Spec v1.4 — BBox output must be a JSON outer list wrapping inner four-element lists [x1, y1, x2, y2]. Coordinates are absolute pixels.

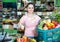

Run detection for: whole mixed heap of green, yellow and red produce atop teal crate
[[38, 19, 58, 30]]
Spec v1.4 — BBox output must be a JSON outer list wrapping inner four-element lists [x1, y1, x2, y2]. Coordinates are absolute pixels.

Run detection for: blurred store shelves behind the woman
[[0, 0, 60, 41]]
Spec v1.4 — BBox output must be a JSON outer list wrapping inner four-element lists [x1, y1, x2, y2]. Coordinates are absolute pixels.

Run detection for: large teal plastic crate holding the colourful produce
[[37, 28, 60, 42]]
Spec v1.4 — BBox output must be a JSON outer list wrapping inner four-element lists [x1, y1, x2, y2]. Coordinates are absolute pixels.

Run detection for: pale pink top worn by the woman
[[20, 15, 41, 37]]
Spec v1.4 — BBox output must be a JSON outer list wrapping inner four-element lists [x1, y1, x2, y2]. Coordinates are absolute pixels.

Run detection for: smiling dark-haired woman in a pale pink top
[[18, 3, 41, 38]]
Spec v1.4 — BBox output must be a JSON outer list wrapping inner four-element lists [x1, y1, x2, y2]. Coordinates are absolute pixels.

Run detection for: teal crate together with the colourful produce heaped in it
[[37, 14, 60, 42]]
